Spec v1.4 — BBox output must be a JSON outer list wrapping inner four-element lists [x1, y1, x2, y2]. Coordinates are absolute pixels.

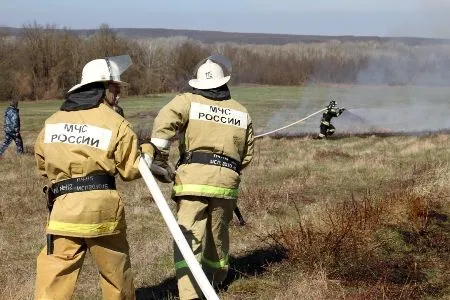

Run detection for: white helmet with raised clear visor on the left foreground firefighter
[[68, 55, 131, 93]]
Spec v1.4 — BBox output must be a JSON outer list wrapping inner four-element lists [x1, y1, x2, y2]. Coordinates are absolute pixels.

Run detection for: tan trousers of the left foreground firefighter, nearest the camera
[[35, 231, 135, 300]]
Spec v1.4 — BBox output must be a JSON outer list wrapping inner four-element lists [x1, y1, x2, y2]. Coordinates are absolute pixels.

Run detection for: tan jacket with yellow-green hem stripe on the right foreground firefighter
[[152, 92, 253, 199]]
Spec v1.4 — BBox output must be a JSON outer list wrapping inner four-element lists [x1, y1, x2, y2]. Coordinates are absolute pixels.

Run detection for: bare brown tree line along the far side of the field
[[0, 23, 450, 100]]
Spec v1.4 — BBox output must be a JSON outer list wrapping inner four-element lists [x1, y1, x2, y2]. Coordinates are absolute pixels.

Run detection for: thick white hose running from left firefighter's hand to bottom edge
[[139, 157, 219, 300]]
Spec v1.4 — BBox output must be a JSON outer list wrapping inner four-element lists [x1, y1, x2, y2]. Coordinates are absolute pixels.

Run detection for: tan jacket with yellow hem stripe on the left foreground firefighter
[[35, 103, 148, 237]]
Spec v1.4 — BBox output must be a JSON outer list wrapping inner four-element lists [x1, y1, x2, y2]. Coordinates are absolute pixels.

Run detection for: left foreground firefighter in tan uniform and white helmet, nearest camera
[[35, 56, 153, 299]]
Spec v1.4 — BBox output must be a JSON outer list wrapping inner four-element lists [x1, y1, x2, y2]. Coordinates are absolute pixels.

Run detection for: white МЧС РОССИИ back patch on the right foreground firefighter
[[189, 102, 247, 129]]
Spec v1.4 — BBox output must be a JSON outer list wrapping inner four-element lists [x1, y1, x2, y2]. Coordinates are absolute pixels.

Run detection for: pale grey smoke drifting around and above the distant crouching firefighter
[[257, 0, 450, 135]]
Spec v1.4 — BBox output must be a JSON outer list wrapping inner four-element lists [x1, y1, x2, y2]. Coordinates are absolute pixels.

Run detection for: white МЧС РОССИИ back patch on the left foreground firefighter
[[44, 123, 112, 150]]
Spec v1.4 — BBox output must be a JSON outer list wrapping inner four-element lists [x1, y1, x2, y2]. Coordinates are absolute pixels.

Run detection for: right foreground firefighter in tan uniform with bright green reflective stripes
[[151, 56, 253, 300]]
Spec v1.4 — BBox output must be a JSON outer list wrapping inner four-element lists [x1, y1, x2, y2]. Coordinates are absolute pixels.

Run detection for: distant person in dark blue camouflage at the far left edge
[[0, 100, 23, 157]]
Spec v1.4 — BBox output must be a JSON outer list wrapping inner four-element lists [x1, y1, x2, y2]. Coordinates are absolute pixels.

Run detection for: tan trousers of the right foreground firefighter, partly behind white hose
[[174, 196, 236, 300]]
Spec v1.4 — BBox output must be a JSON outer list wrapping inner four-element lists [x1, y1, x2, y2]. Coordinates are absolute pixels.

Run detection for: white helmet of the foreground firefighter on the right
[[189, 56, 230, 90]]
